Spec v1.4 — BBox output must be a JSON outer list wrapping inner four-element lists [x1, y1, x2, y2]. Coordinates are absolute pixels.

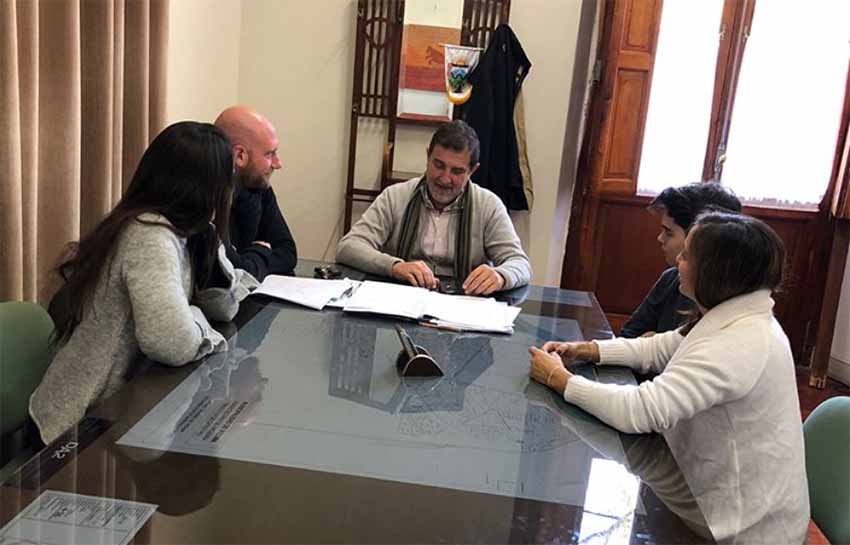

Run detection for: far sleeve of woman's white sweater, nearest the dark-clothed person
[[594, 330, 684, 373]]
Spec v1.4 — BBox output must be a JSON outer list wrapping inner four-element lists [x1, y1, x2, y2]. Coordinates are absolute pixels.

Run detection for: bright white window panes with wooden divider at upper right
[[638, 0, 850, 207]]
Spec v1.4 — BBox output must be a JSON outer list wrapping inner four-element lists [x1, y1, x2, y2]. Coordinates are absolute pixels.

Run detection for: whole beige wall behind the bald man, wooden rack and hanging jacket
[[168, 0, 581, 285]]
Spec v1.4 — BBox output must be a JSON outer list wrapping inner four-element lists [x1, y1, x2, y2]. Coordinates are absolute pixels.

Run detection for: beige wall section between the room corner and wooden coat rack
[[238, 0, 356, 259]]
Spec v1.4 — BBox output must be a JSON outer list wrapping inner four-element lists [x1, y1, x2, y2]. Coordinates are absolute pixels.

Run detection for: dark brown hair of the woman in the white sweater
[[687, 212, 785, 309]]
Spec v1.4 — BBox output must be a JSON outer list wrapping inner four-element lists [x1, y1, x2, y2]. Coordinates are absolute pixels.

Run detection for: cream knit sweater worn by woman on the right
[[564, 290, 809, 545]]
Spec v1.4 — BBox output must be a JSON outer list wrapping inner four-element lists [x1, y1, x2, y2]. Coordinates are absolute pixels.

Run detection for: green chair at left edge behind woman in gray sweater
[[0, 302, 53, 475]]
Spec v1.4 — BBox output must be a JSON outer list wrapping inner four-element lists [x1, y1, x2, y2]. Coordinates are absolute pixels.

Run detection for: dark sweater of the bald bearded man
[[227, 187, 298, 281]]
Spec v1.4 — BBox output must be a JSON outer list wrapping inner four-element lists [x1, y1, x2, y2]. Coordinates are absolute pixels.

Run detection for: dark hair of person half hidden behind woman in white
[[649, 182, 741, 231]]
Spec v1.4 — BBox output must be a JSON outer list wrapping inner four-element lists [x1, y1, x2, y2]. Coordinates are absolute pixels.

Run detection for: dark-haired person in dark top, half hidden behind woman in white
[[620, 182, 741, 338]]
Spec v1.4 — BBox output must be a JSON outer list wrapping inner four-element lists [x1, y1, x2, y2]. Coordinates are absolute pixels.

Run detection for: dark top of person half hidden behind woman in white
[[620, 267, 693, 338]]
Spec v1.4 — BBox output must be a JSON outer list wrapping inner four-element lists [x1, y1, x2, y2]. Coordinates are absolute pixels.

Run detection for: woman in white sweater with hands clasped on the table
[[529, 213, 809, 544]]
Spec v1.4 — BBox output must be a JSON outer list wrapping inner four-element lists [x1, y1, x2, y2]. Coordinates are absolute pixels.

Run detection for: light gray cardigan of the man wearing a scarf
[[336, 178, 531, 289]]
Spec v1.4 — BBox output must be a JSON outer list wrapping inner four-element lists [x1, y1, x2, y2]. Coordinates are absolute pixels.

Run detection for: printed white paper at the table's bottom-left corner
[[0, 490, 157, 545]]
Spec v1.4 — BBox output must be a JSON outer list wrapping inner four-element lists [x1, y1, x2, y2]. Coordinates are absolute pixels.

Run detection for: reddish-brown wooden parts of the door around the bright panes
[[561, 0, 829, 364]]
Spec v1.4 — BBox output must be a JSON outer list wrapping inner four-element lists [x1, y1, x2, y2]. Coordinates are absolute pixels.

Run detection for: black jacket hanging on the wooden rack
[[461, 24, 531, 210]]
